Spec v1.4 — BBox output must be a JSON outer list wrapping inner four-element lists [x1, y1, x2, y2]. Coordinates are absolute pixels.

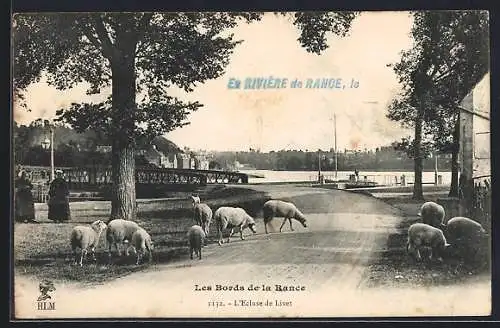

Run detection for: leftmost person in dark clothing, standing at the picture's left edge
[[14, 170, 36, 222]]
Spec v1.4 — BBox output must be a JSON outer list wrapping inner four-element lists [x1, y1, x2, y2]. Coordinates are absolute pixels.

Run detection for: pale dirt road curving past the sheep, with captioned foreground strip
[[16, 186, 488, 318]]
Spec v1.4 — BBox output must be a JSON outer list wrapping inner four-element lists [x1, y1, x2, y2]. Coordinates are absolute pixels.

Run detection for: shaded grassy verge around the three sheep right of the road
[[366, 191, 491, 288]]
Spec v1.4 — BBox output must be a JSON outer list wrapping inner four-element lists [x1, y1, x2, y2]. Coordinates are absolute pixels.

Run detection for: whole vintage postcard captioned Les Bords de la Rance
[[11, 10, 492, 320]]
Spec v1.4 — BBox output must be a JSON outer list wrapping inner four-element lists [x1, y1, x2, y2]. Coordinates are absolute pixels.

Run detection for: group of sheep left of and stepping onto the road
[[70, 196, 307, 266]]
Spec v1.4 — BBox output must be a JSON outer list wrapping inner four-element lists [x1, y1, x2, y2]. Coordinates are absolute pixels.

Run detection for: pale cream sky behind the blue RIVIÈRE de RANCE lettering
[[14, 12, 412, 151]]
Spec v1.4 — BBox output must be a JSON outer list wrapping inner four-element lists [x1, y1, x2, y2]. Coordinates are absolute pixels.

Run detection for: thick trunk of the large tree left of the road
[[111, 33, 137, 220]]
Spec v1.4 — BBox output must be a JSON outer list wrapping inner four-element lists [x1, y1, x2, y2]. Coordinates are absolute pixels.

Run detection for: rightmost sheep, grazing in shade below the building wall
[[444, 216, 488, 258]]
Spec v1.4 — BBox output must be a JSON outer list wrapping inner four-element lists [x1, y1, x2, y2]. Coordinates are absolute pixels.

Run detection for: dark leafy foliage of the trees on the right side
[[387, 10, 489, 152]]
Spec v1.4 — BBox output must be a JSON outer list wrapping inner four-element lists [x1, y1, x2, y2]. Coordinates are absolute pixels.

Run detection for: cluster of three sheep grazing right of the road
[[406, 202, 488, 262]]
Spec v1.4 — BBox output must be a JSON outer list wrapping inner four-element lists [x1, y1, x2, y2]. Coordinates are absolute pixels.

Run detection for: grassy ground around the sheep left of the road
[[14, 187, 268, 284]]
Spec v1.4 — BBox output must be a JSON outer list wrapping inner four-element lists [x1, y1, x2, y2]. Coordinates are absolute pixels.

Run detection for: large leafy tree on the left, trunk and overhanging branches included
[[13, 12, 355, 218]]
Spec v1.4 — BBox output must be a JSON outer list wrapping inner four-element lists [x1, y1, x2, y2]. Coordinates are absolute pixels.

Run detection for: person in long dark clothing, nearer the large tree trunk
[[47, 170, 71, 222]]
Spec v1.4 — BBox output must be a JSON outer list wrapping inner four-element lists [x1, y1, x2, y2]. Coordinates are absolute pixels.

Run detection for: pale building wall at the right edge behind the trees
[[459, 72, 491, 215]]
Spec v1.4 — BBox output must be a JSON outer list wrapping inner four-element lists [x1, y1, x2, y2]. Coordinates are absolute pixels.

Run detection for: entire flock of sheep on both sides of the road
[[71, 196, 487, 266]]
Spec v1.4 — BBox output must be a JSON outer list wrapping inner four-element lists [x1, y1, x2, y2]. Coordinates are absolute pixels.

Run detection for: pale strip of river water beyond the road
[[240, 170, 451, 185]]
